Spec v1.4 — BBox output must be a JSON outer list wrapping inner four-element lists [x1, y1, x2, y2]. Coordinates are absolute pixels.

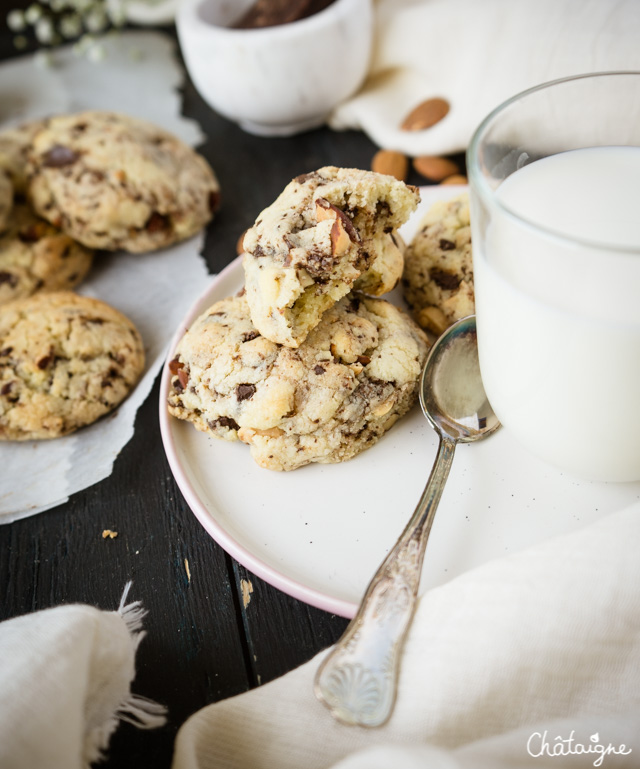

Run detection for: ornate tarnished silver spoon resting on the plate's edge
[[314, 316, 500, 726]]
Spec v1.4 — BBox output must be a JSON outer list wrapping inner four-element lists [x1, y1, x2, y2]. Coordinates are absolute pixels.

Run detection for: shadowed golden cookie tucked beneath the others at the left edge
[[0, 203, 93, 304]]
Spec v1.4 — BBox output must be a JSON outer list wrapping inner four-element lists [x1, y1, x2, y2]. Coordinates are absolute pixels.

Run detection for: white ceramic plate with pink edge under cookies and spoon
[[160, 187, 640, 617]]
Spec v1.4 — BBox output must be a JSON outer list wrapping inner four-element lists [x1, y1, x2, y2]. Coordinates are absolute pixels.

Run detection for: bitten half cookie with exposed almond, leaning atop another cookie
[[244, 166, 419, 347]]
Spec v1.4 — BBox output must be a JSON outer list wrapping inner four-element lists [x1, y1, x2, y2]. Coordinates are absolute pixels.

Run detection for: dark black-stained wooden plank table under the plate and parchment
[[0, 15, 462, 769]]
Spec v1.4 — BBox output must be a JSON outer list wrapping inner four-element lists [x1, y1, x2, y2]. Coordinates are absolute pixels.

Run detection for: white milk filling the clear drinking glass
[[472, 147, 640, 481]]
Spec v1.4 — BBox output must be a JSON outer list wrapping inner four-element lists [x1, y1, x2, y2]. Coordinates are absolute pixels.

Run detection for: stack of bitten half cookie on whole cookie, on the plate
[[169, 166, 428, 470]]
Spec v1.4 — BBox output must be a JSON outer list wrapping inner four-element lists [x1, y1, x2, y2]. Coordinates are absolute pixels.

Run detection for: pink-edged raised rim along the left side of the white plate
[[159, 256, 357, 618]]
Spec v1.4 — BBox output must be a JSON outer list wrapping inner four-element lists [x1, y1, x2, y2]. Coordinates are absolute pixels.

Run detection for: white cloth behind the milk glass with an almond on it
[[330, 0, 640, 157]]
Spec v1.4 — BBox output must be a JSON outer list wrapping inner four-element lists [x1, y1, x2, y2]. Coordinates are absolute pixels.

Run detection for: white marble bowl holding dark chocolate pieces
[[176, 0, 372, 136]]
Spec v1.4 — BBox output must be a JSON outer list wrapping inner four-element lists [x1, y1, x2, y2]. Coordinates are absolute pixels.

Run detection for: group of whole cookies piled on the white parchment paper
[[0, 111, 219, 440]]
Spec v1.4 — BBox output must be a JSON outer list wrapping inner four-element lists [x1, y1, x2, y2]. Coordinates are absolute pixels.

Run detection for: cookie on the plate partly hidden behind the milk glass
[[402, 193, 475, 334]]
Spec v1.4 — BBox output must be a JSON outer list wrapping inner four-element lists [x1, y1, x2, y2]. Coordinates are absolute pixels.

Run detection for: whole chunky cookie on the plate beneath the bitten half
[[169, 293, 428, 470]]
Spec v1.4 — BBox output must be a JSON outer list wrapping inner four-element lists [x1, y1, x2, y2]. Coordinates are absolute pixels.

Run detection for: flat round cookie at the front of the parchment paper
[[0, 291, 144, 441]]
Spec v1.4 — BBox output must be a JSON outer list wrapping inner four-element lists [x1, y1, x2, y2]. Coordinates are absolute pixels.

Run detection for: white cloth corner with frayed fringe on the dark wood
[[0, 583, 165, 769]]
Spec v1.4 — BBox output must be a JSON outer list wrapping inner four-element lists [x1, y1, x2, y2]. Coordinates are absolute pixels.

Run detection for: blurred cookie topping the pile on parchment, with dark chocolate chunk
[[27, 111, 219, 252]]
